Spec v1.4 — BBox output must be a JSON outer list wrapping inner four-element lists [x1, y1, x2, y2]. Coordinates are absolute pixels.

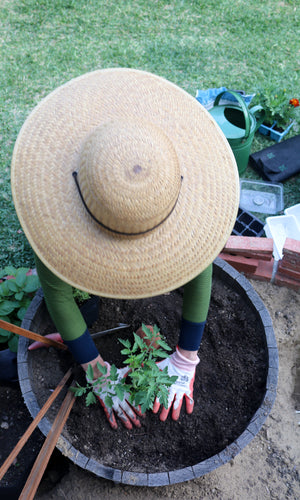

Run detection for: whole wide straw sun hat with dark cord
[[11, 68, 239, 298]]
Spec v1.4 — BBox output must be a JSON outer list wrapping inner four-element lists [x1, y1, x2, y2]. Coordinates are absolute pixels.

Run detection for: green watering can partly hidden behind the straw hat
[[209, 90, 265, 175]]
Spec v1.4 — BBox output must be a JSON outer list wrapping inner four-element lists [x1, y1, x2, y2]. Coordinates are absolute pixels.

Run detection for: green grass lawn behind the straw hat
[[0, 0, 300, 267]]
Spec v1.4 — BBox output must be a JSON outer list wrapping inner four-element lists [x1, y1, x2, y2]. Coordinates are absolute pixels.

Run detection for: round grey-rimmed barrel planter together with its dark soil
[[18, 259, 278, 487]]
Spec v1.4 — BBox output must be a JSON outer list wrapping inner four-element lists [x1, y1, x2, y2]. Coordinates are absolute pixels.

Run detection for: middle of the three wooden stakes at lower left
[[0, 368, 72, 481]]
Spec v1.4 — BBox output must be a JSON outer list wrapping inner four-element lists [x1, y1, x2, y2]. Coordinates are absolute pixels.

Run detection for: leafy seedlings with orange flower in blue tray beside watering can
[[256, 88, 299, 142]]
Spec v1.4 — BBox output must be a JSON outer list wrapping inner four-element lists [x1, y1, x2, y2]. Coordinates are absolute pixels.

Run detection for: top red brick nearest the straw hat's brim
[[223, 235, 273, 256]]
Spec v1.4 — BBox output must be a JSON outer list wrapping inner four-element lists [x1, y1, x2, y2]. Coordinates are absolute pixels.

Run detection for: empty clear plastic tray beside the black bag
[[240, 179, 284, 215]]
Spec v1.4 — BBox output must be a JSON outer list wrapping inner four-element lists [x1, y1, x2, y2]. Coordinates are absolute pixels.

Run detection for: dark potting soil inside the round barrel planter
[[30, 278, 267, 473]]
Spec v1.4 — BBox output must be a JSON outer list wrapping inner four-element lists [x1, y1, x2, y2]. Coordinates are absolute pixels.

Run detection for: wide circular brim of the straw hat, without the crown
[[11, 68, 239, 298]]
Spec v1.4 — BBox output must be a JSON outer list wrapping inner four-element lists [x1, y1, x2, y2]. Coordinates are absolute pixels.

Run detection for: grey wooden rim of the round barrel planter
[[18, 258, 278, 487]]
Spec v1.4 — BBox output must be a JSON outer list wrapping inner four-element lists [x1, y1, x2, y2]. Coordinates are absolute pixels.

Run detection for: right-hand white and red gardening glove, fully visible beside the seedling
[[153, 348, 200, 422]]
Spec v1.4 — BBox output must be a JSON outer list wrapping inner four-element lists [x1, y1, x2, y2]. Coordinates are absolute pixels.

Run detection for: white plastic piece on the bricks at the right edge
[[264, 215, 300, 260]]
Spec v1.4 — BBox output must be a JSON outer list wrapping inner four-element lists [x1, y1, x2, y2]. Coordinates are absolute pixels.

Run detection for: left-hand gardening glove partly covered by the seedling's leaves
[[86, 362, 143, 429]]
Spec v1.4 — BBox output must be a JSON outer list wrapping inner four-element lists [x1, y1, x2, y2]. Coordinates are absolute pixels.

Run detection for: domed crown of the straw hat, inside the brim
[[78, 119, 181, 234]]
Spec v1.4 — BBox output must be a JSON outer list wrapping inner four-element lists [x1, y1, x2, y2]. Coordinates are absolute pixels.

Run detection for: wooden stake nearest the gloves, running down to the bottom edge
[[19, 380, 75, 500]]
